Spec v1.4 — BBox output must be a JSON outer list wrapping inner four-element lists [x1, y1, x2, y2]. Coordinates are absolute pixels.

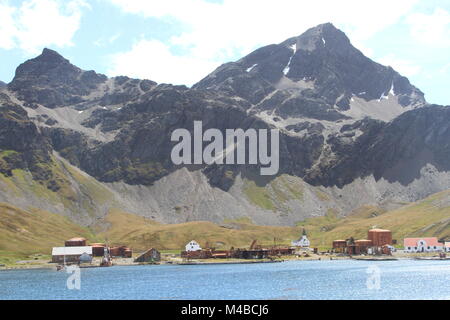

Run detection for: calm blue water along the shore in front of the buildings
[[0, 260, 450, 300]]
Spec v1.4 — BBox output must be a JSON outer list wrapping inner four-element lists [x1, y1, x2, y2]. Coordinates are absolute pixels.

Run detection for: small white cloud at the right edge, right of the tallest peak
[[406, 8, 450, 48]]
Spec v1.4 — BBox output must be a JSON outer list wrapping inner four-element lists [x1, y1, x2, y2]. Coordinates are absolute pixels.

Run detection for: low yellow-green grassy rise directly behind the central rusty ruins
[[99, 211, 300, 250]]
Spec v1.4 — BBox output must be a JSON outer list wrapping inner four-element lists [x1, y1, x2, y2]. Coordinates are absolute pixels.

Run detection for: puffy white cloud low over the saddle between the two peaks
[[107, 40, 216, 85]]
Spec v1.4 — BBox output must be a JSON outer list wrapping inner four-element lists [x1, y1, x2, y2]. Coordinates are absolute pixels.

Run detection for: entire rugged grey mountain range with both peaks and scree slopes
[[0, 24, 450, 226]]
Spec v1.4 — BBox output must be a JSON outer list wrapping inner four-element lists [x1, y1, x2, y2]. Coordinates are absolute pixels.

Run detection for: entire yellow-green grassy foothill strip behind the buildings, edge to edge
[[0, 190, 450, 263]]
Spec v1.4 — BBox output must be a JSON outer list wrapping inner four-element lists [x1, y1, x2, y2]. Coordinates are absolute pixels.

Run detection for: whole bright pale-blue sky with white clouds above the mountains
[[0, 0, 450, 105]]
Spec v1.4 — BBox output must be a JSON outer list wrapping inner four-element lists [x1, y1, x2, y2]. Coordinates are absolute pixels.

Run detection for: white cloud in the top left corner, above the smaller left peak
[[0, 0, 88, 54]]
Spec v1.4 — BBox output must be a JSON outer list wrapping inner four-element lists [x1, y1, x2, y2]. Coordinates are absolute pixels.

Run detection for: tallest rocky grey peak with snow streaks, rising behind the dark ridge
[[194, 23, 425, 121]]
